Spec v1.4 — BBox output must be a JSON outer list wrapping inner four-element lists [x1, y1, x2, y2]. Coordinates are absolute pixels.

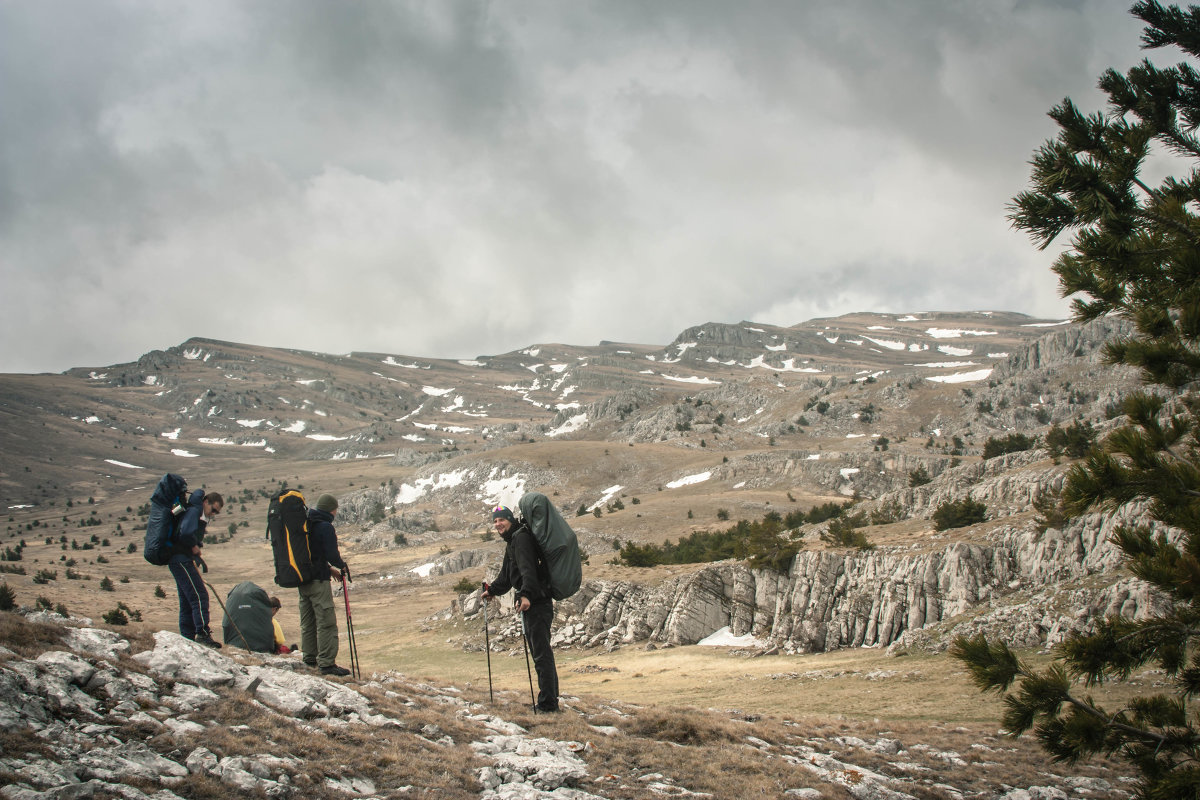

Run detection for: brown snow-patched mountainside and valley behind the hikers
[[0, 313, 1157, 800]]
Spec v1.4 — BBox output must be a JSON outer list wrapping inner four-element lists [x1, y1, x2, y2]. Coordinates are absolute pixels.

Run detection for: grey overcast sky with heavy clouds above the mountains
[[0, 0, 1161, 372]]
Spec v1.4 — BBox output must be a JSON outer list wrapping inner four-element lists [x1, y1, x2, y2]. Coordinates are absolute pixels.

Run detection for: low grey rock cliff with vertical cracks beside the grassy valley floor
[[549, 501, 1163, 652]]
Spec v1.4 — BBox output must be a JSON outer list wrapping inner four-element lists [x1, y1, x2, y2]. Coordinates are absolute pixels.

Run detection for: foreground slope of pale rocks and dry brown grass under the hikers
[[0, 613, 1132, 800]]
